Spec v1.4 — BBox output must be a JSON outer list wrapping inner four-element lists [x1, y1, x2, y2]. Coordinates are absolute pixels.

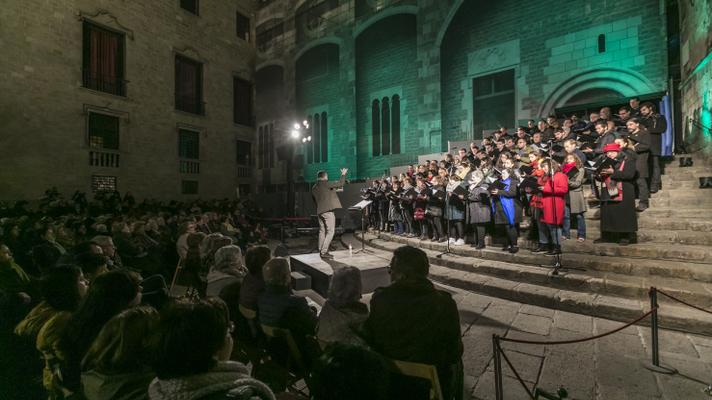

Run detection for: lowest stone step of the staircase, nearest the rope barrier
[[430, 265, 712, 335]]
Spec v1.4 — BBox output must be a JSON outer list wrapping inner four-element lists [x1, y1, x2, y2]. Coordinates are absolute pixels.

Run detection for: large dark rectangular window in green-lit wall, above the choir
[[472, 69, 514, 138]]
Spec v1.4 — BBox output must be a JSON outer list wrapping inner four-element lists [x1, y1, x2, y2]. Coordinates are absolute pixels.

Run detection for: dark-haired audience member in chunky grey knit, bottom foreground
[[148, 298, 275, 400]]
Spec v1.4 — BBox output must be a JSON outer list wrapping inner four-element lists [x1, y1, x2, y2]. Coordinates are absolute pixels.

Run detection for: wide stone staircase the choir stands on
[[358, 156, 712, 335]]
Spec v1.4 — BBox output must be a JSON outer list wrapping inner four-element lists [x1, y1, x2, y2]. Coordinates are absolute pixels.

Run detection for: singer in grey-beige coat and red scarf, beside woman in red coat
[[561, 153, 588, 242]]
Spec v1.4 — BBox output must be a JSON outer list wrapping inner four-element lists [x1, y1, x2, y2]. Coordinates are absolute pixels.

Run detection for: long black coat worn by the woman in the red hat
[[601, 153, 638, 232]]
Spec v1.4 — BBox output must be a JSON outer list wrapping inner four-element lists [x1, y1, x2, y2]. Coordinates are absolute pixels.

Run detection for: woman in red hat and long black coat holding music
[[594, 139, 638, 246]]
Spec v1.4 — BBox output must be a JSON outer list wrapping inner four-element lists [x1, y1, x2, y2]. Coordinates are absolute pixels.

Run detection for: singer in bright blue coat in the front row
[[489, 169, 522, 254]]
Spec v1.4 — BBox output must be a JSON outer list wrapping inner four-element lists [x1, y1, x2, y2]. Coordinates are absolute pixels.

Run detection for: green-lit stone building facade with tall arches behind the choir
[[255, 0, 709, 187]]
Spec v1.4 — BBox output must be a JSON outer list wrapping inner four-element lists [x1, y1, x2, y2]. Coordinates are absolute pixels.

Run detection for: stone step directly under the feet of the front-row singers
[[370, 233, 712, 283]]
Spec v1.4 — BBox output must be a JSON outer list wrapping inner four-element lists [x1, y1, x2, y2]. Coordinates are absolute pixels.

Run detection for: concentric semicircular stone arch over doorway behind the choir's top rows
[[538, 67, 656, 115]]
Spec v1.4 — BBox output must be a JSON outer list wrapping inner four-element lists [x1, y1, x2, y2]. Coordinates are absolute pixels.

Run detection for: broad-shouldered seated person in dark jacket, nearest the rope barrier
[[364, 246, 463, 399]]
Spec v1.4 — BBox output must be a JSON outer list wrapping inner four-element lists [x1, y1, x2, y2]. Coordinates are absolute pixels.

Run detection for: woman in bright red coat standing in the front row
[[536, 160, 569, 255]]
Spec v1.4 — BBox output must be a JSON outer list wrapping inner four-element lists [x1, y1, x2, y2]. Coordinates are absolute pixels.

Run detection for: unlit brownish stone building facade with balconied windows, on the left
[[0, 0, 255, 200]]
